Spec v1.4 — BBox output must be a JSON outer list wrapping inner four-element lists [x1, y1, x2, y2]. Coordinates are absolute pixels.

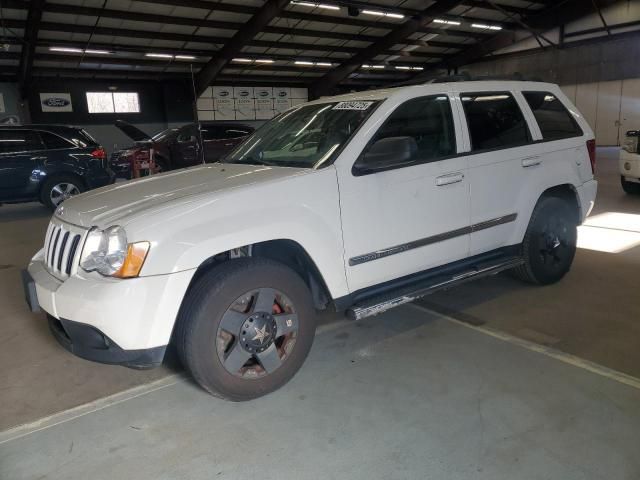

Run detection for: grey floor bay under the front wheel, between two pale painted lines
[[0, 306, 640, 480]]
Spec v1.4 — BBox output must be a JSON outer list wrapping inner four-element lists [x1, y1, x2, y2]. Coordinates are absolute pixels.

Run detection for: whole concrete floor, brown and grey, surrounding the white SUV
[[0, 150, 640, 480]]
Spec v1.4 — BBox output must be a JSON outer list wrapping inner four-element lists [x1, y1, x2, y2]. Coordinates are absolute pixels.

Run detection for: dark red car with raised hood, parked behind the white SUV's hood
[[110, 120, 254, 178]]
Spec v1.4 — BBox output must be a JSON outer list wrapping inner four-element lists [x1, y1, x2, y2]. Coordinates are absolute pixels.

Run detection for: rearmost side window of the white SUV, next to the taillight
[[522, 92, 583, 140]]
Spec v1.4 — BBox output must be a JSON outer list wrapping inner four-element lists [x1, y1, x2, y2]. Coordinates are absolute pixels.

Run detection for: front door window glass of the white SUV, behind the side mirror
[[365, 95, 456, 166]]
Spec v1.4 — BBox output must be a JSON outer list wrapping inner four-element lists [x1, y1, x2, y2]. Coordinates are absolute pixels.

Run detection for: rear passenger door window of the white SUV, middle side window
[[460, 92, 531, 152]]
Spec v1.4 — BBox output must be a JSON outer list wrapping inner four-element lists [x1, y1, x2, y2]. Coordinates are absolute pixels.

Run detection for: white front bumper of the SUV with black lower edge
[[23, 251, 195, 368]]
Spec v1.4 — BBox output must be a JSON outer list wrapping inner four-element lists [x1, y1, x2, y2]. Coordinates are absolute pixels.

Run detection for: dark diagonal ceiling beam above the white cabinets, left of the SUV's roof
[[195, 0, 289, 96]]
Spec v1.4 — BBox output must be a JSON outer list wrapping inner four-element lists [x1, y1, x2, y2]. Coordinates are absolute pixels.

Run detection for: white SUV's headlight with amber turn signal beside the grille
[[80, 226, 149, 278]]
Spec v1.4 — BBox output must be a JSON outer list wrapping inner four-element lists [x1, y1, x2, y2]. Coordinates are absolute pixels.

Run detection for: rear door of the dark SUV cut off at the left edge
[[0, 129, 47, 200]]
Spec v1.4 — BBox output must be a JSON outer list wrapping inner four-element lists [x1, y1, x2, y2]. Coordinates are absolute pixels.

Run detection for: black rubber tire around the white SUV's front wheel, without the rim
[[174, 258, 316, 401]]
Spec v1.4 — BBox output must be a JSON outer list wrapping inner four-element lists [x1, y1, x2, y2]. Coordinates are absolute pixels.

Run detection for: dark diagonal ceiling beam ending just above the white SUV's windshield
[[312, 0, 460, 96]]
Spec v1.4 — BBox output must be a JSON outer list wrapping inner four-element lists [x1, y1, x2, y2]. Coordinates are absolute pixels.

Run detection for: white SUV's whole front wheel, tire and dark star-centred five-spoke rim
[[175, 258, 315, 401]]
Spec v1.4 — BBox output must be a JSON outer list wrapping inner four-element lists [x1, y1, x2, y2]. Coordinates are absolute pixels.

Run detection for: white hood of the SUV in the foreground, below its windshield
[[55, 163, 313, 228]]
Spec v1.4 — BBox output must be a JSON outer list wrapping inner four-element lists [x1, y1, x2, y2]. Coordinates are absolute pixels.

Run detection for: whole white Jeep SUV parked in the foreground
[[23, 81, 596, 400]]
